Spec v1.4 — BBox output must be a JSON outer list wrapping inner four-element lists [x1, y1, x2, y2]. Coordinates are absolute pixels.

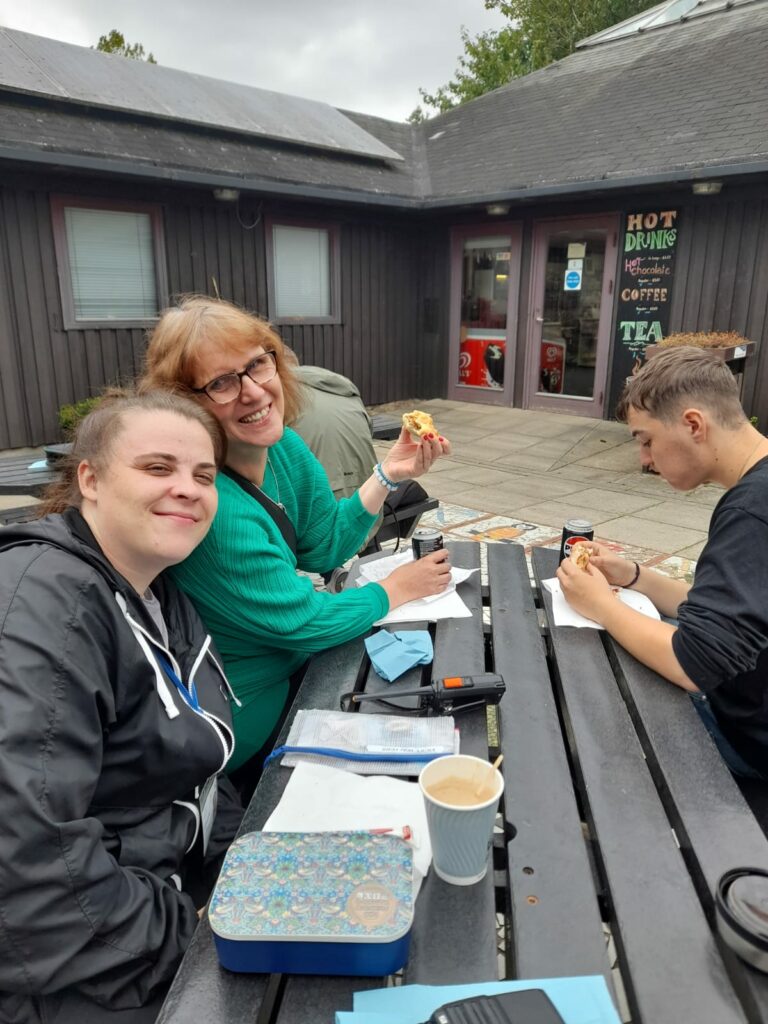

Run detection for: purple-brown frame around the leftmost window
[[50, 196, 168, 331]]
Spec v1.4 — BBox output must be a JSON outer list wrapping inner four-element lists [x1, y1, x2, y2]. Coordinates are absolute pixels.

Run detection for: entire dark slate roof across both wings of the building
[[0, 0, 768, 207]]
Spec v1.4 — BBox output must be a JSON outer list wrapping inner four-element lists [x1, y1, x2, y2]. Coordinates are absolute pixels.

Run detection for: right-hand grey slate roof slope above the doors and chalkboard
[[426, 0, 768, 201]]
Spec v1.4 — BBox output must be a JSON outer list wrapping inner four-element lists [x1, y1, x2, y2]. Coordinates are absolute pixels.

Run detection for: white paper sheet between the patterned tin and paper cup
[[264, 762, 432, 895]]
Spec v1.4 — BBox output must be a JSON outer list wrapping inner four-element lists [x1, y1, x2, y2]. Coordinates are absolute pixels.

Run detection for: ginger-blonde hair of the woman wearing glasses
[[139, 295, 301, 424]]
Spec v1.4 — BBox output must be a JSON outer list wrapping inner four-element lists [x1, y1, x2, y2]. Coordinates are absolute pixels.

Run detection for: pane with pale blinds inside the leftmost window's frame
[[65, 207, 158, 321]]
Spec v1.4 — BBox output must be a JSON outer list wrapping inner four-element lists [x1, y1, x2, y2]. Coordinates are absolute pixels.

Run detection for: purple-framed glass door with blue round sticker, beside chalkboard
[[526, 216, 617, 418]]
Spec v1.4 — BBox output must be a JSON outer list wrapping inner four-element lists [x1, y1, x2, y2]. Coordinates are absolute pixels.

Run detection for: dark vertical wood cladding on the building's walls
[[0, 175, 768, 449]]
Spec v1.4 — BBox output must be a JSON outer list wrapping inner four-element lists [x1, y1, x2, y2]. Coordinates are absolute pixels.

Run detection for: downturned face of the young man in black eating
[[627, 408, 708, 490]]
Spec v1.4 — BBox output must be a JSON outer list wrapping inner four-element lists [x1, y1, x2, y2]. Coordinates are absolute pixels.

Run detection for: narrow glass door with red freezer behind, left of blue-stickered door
[[450, 224, 520, 402]]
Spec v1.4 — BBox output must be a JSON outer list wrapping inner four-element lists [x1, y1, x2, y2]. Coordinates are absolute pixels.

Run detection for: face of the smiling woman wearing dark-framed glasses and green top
[[194, 345, 285, 454]]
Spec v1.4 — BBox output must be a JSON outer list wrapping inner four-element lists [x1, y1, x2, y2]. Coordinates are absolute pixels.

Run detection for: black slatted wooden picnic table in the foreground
[[159, 542, 768, 1024]]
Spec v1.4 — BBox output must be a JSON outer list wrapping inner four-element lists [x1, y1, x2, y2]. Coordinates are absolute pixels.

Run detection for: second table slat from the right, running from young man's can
[[532, 550, 744, 1024]]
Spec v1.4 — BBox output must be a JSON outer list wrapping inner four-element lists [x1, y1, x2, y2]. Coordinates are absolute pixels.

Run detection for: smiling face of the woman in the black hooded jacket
[[78, 410, 218, 593]]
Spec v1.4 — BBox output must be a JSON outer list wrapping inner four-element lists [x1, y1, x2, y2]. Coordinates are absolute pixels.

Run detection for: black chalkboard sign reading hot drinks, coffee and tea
[[610, 210, 679, 407]]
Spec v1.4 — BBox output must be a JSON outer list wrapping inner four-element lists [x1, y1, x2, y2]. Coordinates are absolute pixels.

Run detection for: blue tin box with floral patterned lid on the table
[[208, 831, 414, 976]]
